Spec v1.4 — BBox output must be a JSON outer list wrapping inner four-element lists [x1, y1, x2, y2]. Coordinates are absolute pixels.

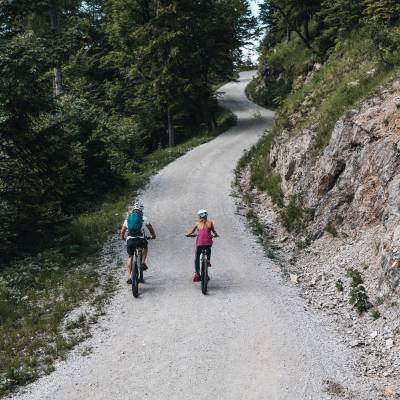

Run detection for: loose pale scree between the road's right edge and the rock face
[[237, 165, 400, 400]]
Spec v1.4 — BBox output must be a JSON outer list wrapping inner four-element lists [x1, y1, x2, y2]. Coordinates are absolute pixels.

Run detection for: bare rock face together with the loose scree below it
[[237, 79, 400, 399]]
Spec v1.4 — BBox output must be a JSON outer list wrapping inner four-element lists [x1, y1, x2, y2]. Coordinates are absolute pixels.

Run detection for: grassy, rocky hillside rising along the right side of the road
[[237, 2, 400, 398]]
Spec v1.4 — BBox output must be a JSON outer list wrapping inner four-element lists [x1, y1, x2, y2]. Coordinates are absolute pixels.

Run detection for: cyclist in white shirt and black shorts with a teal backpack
[[120, 202, 156, 284]]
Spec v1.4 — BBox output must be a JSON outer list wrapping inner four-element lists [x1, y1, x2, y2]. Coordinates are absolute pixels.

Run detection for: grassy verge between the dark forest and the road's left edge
[[0, 109, 236, 396]]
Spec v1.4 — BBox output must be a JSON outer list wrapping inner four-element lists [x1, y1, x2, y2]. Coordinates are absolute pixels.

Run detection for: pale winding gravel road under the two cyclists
[[13, 72, 363, 400]]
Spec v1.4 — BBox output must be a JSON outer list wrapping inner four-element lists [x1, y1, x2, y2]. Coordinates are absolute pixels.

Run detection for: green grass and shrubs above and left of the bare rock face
[[238, 27, 400, 242]]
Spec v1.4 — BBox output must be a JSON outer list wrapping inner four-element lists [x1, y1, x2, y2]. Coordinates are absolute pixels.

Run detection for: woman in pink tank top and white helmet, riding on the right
[[186, 210, 219, 282]]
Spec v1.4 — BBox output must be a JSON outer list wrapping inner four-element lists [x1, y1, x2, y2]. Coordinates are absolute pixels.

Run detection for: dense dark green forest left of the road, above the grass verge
[[0, 0, 255, 261]]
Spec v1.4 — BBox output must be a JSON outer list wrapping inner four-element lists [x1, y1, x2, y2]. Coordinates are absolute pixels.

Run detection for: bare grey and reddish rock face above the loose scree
[[270, 79, 400, 291]]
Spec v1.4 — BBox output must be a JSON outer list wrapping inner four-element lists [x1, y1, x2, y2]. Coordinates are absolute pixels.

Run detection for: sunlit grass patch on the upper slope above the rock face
[[278, 31, 399, 151]]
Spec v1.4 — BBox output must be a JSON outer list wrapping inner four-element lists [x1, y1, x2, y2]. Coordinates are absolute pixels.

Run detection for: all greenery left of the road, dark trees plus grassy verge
[[0, 0, 256, 395]]
